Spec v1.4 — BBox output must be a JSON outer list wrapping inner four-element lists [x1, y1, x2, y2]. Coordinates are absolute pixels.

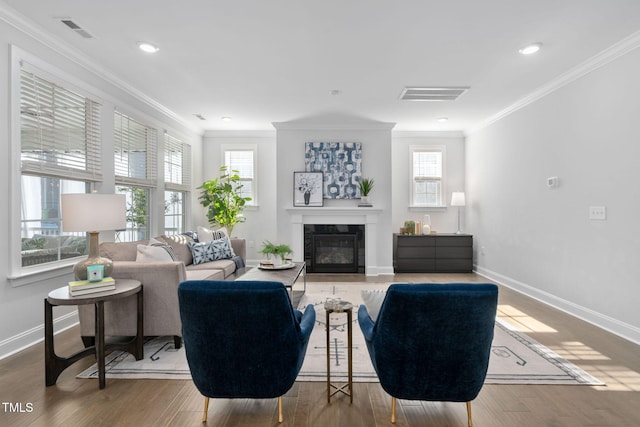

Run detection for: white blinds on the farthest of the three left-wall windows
[[164, 133, 191, 191]]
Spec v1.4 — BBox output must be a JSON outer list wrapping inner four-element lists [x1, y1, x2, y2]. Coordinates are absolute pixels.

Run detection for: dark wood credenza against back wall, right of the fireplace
[[393, 234, 473, 273]]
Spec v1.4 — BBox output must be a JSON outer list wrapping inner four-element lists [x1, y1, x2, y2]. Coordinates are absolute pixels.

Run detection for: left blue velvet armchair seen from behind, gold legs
[[178, 280, 315, 422]]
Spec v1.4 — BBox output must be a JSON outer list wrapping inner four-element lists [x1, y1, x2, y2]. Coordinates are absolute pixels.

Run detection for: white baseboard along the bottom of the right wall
[[475, 266, 640, 345]]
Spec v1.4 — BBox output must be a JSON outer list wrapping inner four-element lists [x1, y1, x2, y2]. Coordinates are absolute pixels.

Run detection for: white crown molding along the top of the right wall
[[465, 31, 640, 136]]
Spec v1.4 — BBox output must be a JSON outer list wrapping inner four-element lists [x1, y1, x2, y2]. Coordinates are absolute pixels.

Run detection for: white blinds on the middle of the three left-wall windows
[[114, 111, 158, 187]]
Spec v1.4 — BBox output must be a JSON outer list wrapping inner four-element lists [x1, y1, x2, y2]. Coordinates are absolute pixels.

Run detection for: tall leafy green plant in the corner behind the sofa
[[198, 166, 251, 235]]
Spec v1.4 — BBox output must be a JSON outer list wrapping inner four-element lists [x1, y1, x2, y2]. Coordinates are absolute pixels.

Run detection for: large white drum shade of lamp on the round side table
[[62, 193, 127, 232]]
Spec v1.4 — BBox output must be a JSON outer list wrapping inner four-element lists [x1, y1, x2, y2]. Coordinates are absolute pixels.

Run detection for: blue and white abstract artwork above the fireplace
[[304, 142, 362, 199]]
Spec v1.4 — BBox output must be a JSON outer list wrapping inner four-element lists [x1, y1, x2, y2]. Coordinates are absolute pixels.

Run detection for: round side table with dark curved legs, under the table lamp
[[44, 279, 144, 389]]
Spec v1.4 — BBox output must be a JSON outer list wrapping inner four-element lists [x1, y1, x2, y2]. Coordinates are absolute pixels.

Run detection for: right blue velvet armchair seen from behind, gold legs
[[358, 283, 498, 427]]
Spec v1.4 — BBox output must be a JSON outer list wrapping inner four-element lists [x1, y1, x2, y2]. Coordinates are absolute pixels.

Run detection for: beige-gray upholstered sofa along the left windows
[[78, 235, 246, 348]]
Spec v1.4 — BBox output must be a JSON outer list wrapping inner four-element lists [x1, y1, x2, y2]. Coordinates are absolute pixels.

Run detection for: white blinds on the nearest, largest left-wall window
[[20, 69, 102, 181]]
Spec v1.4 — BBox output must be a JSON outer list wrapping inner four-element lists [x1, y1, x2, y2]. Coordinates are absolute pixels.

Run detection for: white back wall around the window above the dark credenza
[[392, 132, 468, 233]]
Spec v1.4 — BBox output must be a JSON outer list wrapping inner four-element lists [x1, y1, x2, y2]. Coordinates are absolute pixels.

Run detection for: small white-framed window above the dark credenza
[[410, 146, 444, 207]]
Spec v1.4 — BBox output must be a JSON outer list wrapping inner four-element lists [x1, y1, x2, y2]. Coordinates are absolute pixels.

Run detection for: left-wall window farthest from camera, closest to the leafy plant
[[164, 133, 191, 234]]
